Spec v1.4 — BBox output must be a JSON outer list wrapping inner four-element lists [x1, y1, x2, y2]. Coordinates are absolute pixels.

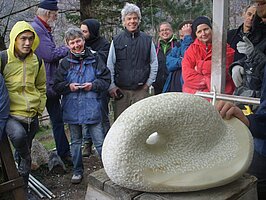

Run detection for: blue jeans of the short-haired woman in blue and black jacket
[[68, 123, 104, 175]]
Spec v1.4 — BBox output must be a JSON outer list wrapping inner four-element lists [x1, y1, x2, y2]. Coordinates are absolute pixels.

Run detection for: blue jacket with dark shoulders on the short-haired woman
[[53, 48, 111, 124]]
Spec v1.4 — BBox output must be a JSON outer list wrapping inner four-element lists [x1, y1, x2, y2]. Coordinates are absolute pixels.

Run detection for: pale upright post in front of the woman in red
[[211, 0, 229, 93]]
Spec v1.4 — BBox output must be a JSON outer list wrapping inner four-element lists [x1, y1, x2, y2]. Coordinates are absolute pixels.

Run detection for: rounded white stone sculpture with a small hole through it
[[102, 93, 253, 192]]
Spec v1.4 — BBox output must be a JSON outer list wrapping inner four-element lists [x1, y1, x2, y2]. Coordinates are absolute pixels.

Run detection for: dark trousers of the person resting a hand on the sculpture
[[248, 151, 266, 200]]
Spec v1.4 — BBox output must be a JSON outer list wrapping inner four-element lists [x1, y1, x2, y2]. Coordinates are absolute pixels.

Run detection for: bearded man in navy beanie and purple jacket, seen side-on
[[31, 0, 72, 164]]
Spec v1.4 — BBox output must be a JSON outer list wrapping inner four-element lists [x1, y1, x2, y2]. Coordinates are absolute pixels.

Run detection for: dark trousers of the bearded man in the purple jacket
[[46, 97, 70, 158]]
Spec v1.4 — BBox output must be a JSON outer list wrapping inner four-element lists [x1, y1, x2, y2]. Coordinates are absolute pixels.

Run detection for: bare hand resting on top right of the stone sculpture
[[215, 101, 249, 126]]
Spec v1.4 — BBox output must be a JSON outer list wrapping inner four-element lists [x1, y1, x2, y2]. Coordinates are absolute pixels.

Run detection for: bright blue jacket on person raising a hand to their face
[[163, 35, 193, 92]]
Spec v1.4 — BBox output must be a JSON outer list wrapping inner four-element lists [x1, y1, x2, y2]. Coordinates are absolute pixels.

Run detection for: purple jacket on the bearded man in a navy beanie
[[31, 17, 69, 98]]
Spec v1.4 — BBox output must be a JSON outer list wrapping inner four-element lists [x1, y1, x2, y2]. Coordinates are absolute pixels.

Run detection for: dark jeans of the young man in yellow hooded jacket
[[5, 116, 39, 187]]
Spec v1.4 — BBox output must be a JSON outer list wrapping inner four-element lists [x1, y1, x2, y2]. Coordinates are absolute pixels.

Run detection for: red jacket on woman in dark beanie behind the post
[[182, 39, 235, 94]]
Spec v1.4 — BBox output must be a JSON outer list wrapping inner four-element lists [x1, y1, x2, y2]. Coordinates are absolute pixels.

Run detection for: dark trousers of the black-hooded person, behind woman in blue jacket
[[83, 91, 111, 143]]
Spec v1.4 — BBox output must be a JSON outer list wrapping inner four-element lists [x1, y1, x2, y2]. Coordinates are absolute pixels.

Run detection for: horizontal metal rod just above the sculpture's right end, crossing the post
[[195, 92, 260, 105]]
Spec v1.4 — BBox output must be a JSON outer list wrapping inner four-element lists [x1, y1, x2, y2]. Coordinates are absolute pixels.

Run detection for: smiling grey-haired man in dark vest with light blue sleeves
[[107, 3, 158, 119]]
